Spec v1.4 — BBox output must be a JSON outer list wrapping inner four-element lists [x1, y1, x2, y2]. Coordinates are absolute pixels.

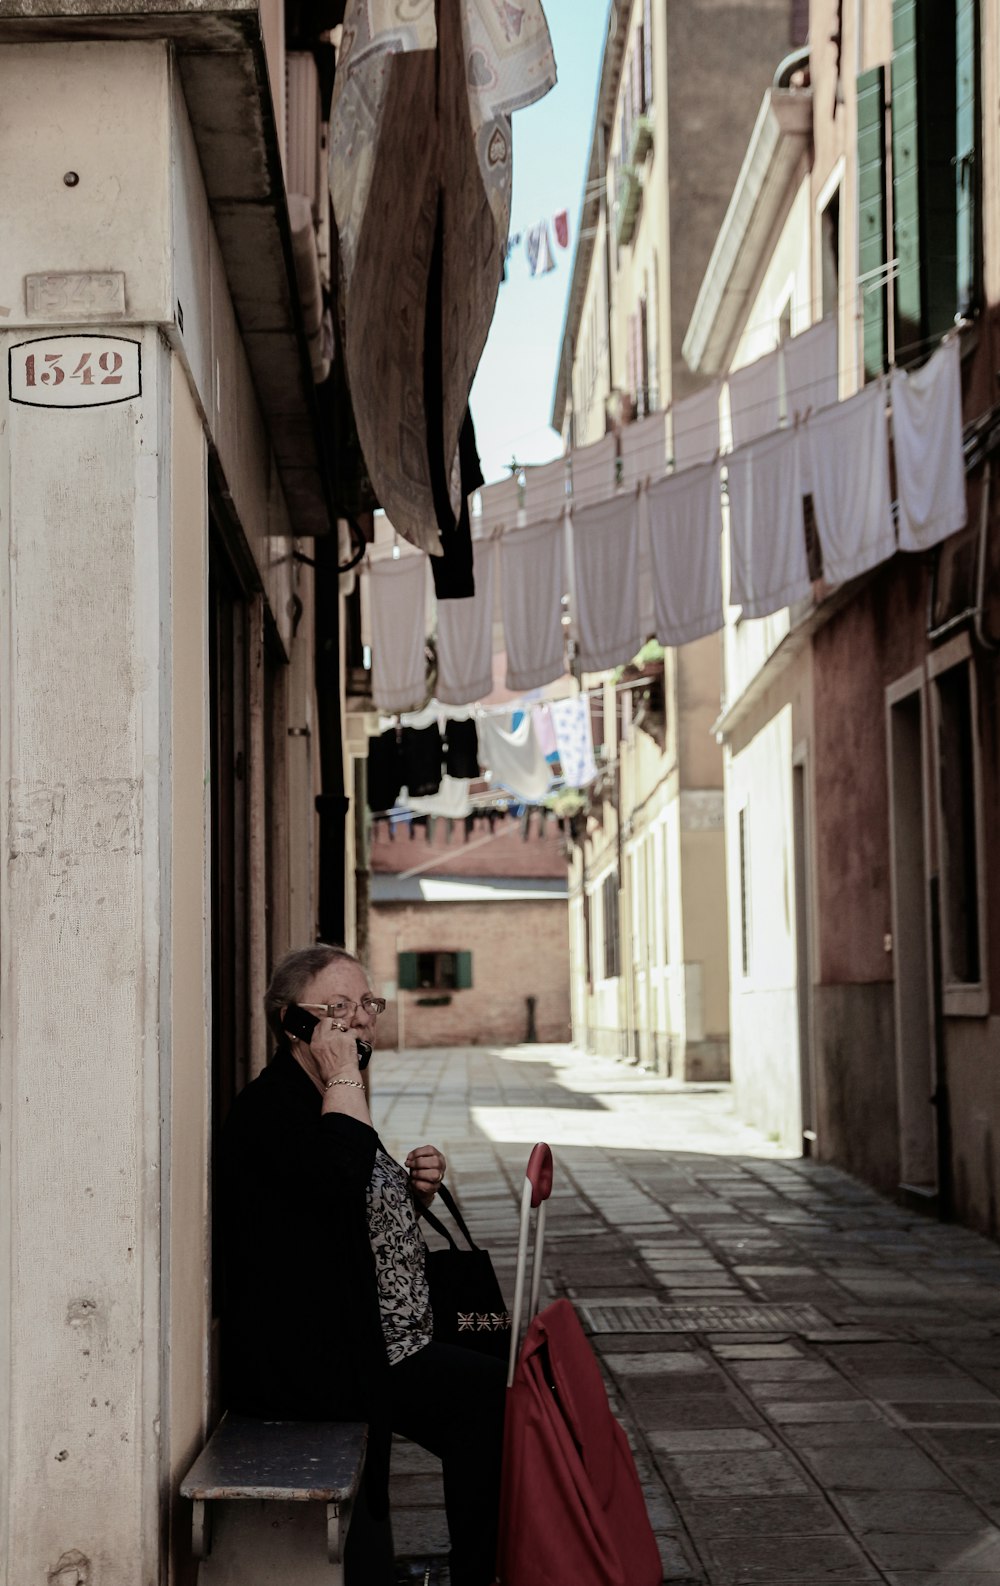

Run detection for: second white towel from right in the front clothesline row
[[805, 381, 895, 584]]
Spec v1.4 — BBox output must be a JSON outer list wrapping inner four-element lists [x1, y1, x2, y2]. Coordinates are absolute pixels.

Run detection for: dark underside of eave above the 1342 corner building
[[0, 0, 333, 536]]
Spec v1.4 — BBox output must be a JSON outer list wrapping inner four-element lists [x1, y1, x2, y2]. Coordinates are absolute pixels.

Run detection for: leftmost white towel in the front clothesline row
[[368, 552, 426, 712]]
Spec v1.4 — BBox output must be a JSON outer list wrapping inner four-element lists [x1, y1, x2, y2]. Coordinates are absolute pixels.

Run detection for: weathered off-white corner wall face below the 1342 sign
[[0, 325, 170, 1586]]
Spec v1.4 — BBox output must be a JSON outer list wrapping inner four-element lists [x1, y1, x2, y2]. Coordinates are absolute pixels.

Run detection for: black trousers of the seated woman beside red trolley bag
[[388, 1343, 507, 1586]]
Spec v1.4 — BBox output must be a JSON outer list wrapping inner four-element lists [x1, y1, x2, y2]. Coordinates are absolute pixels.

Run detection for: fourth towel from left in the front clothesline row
[[572, 495, 642, 672]]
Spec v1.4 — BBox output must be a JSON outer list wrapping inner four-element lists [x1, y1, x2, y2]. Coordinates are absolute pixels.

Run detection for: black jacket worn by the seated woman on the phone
[[216, 1047, 390, 1511]]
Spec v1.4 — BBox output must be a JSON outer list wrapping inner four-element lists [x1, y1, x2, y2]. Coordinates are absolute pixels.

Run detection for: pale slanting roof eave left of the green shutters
[[681, 87, 813, 374]]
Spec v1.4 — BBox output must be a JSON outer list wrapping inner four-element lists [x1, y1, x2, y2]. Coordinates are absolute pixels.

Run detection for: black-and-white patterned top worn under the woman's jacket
[[368, 1145, 433, 1366]]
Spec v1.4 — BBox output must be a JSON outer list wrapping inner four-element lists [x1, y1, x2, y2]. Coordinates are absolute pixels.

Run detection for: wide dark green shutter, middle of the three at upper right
[[892, 0, 957, 363]]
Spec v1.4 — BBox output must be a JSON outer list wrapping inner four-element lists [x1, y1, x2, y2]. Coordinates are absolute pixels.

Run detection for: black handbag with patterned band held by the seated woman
[[423, 1185, 510, 1361]]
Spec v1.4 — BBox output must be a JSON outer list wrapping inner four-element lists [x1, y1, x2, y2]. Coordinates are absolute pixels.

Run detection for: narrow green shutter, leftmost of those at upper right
[[857, 67, 887, 379]]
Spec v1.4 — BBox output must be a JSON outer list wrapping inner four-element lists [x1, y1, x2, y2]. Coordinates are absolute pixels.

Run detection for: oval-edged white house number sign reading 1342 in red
[[8, 335, 143, 408]]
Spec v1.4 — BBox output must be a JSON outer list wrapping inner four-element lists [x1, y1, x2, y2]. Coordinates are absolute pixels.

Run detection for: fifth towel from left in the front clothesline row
[[648, 463, 724, 646]]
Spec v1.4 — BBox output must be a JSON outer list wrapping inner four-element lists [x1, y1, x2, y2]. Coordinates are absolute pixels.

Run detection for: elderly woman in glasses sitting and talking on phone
[[217, 944, 504, 1586]]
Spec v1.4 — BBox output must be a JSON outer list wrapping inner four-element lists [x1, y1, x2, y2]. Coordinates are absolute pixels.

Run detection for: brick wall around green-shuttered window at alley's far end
[[369, 899, 569, 1047]]
